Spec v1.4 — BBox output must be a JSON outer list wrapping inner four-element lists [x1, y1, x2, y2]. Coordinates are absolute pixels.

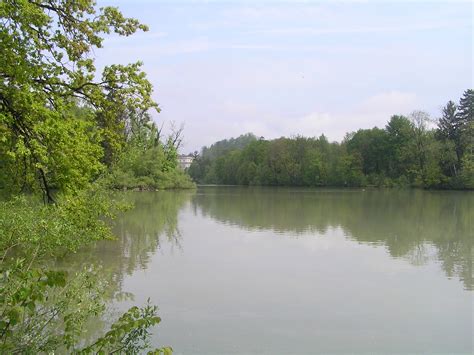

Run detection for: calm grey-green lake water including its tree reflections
[[68, 187, 474, 354]]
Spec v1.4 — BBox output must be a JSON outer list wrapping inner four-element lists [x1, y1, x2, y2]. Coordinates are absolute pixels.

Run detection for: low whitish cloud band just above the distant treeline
[[181, 91, 419, 149]]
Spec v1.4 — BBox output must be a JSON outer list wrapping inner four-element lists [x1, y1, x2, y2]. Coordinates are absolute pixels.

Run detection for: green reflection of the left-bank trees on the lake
[[56, 191, 194, 299]]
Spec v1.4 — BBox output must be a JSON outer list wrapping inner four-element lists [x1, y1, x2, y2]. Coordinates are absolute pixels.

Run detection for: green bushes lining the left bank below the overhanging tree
[[0, 190, 170, 353]]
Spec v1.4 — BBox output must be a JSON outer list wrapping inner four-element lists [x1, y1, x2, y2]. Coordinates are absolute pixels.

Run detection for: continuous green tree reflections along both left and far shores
[[58, 187, 474, 297]]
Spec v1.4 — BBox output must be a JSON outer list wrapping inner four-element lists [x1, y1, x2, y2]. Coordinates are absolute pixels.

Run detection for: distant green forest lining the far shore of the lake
[[188, 89, 474, 189]]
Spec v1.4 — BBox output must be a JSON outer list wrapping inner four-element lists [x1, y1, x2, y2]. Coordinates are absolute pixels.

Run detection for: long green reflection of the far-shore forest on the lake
[[192, 187, 474, 290]]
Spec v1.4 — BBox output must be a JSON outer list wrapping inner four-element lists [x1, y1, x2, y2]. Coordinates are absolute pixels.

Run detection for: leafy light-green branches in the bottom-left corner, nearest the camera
[[0, 261, 171, 354]]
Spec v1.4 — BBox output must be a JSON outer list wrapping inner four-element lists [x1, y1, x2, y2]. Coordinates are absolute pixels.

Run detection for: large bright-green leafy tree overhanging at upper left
[[0, 0, 157, 202]]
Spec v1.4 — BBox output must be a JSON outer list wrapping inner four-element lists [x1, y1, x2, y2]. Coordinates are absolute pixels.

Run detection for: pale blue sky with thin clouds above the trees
[[95, 0, 474, 153]]
